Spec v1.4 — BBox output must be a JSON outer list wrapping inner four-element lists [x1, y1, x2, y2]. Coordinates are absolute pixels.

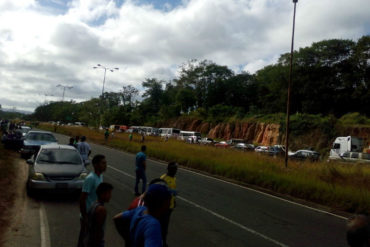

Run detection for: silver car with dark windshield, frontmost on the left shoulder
[[27, 144, 87, 194]]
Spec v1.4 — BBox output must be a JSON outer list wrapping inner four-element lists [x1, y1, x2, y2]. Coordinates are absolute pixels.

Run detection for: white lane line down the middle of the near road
[[108, 166, 288, 247]]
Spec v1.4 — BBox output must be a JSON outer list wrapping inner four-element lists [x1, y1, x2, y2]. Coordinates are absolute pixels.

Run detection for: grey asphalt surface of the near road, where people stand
[[27, 134, 347, 247]]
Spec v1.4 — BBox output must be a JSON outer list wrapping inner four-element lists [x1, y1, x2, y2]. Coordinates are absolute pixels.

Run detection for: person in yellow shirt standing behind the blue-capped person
[[160, 162, 178, 247]]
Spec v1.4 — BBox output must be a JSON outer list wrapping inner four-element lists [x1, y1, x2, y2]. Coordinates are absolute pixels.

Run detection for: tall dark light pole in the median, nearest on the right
[[285, 0, 298, 167]]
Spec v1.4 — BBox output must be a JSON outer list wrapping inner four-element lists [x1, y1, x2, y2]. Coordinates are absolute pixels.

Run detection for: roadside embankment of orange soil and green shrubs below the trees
[[157, 114, 370, 153]]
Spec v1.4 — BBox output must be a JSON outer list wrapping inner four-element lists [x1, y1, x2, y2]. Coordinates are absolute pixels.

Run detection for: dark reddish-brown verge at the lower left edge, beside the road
[[0, 145, 17, 246]]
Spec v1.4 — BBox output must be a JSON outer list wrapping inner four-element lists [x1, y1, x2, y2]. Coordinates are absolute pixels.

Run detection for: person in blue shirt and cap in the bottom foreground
[[113, 184, 171, 247]]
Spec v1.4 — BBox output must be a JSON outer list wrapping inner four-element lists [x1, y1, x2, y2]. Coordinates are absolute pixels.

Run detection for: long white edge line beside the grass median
[[62, 134, 348, 220]]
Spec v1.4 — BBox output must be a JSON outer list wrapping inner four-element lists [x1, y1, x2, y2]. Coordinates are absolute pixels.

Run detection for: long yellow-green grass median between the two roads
[[39, 124, 370, 213]]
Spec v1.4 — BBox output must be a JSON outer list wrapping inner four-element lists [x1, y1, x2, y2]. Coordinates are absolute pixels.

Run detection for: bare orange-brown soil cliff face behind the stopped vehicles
[[158, 118, 370, 152]]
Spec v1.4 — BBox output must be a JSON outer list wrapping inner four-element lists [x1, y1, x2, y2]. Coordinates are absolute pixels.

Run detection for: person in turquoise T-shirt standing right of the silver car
[[77, 154, 107, 247]]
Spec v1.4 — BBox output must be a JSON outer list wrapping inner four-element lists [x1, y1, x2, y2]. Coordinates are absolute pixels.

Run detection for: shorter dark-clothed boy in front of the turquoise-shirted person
[[85, 183, 113, 247]]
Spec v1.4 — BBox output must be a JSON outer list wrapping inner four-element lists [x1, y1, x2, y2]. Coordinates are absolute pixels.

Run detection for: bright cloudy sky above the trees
[[0, 0, 370, 111]]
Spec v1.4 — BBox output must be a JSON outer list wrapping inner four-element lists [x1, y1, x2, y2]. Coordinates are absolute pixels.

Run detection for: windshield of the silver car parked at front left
[[37, 149, 82, 165]]
